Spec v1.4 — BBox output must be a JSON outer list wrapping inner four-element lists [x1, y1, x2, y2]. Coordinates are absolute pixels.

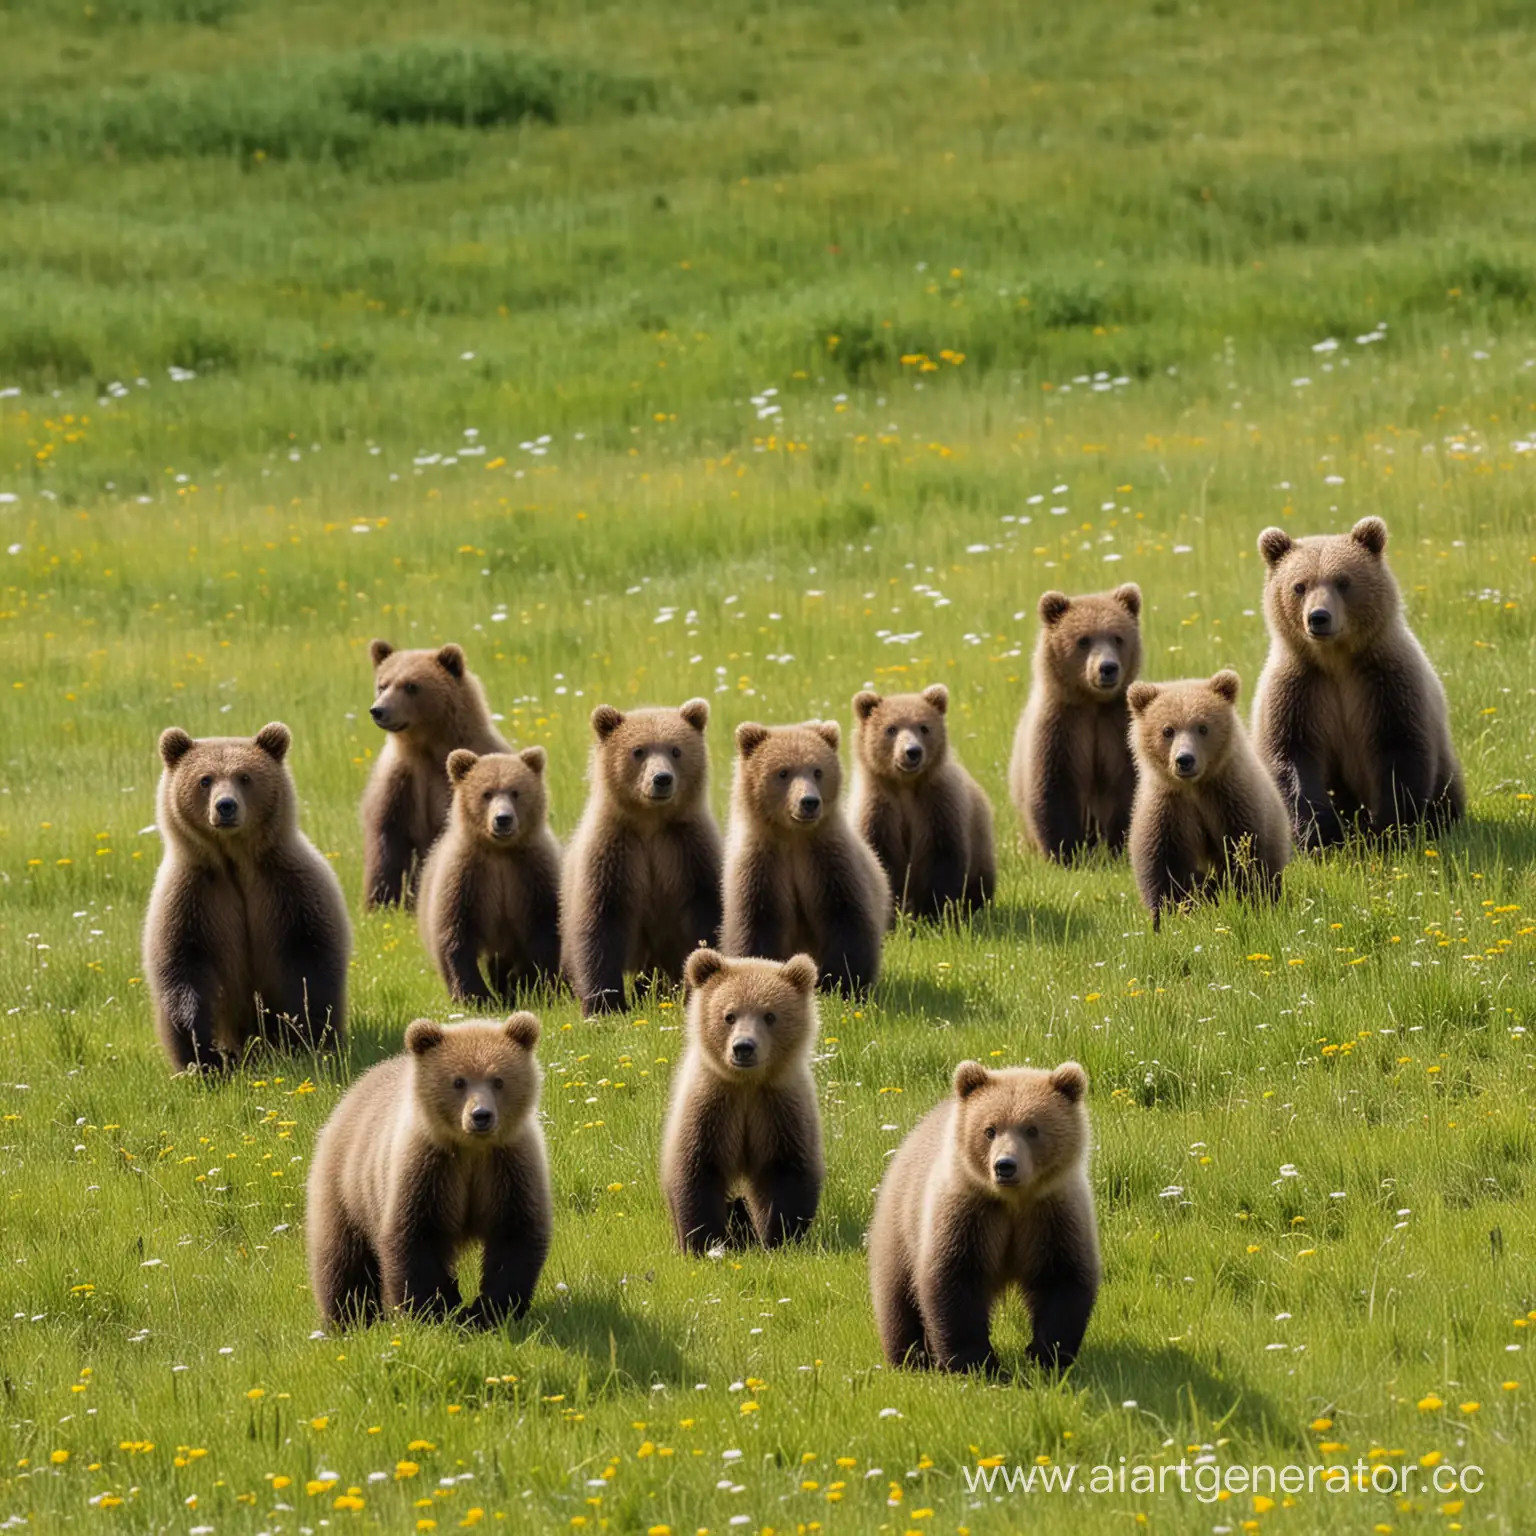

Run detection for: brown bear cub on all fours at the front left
[[309, 1014, 553, 1327]]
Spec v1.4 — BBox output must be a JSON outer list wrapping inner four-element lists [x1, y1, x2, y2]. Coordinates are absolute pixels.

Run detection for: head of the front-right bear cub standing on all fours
[[954, 1061, 1089, 1200]]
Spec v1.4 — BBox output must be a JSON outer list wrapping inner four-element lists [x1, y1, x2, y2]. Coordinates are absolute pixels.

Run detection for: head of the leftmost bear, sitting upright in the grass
[[158, 720, 298, 851]]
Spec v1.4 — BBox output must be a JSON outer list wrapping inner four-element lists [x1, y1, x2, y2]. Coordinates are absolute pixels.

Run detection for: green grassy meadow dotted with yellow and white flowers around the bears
[[0, 0, 1536, 1536]]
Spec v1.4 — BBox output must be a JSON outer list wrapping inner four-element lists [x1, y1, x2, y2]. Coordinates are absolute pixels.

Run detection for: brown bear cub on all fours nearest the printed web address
[[869, 1061, 1100, 1370]]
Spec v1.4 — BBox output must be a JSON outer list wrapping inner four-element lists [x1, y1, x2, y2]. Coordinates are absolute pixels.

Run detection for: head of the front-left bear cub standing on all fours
[[406, 1012, 542, 1147]]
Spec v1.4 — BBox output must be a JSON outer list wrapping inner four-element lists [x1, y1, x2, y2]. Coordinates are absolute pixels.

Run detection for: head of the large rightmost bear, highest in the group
[[1258, 518, 1402, 659]]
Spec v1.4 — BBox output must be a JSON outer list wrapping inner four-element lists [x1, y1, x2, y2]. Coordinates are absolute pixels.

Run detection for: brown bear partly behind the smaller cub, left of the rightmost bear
[[1008, 584, 1141, 860]]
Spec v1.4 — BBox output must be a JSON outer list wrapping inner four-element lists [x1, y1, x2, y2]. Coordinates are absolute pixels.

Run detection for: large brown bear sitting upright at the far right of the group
[[1253, 518, 1467, 848]]
